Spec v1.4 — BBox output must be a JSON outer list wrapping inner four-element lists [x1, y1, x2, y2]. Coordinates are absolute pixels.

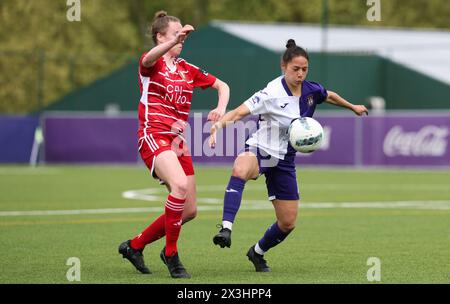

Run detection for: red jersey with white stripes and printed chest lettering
[[138, 53, 216, 139]]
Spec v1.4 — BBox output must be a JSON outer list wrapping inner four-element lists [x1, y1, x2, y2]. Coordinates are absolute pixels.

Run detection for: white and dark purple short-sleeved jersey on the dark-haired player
[[244, 76, 327, 161]]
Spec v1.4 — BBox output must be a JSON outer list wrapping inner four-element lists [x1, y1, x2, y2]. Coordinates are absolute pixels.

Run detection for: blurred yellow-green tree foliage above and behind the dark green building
[[0, 0, 450, 113]]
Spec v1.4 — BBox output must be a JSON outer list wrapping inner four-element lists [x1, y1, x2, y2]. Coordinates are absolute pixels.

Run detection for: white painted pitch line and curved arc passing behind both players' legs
[[0, 188, 450, 217]]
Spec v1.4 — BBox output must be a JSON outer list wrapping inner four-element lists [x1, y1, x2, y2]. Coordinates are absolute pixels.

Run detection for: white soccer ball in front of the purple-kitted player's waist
[[288, 117, 323, 153]]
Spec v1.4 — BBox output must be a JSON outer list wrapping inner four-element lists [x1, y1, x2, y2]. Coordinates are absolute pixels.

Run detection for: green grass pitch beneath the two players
[[0, 166, 450, 283]]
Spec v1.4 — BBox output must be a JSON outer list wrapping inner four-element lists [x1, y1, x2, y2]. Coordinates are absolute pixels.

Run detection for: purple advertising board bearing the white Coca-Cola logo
[[362, 115, 450, 166]]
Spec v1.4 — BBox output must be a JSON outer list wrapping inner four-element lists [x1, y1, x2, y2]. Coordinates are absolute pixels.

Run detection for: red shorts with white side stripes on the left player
[[139, 133, 194, 178]]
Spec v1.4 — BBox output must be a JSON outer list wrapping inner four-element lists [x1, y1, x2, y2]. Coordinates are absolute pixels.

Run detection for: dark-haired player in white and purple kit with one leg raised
[[210, 39, 368, 272]]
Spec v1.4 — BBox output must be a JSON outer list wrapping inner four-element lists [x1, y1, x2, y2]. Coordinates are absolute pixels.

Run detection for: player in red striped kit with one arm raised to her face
[[119, 11, 230, 278]]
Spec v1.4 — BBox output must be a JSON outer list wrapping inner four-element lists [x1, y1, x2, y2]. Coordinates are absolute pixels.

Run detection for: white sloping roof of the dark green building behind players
[[212, 21, 450, 85]]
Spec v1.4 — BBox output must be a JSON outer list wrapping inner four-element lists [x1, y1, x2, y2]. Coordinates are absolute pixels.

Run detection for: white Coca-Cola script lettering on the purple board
[[383, 125, 449, 157]]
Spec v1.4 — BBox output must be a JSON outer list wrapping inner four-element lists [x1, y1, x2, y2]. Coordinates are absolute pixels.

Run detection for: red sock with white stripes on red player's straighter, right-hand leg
[[165, 194, 186, 256]]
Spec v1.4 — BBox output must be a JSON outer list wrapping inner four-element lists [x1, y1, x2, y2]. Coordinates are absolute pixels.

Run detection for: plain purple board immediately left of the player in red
[[44, 116, 138, 163]]
